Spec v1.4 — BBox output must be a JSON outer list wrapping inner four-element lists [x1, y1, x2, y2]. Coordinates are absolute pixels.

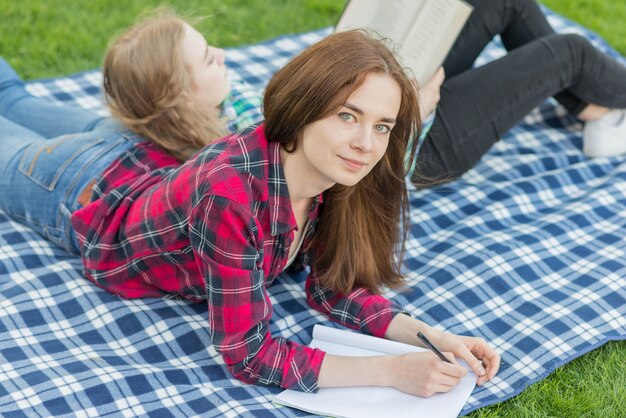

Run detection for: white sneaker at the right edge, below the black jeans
[[583, 109, 626, 158]]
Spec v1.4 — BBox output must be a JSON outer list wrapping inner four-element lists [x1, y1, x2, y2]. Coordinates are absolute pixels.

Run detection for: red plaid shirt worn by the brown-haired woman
[[72, 125, 401, 391]]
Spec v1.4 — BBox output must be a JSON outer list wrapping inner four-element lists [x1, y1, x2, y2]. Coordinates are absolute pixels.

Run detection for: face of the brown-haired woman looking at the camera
[[296, 74, 402, 188]]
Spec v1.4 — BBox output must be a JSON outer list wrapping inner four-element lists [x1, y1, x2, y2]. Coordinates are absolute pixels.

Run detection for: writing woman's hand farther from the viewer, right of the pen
[[428, 329, 500, 386]]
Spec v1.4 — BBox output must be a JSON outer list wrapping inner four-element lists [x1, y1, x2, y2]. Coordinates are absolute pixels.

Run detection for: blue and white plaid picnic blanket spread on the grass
[[0, 8, 626, 417]]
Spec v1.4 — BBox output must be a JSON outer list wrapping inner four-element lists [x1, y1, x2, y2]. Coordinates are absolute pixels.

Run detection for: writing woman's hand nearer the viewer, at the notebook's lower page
[[389, 352, 467, 397]]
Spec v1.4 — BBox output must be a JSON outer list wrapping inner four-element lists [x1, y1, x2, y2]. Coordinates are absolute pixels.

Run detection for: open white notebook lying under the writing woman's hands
[[273, 325, 477, 418]]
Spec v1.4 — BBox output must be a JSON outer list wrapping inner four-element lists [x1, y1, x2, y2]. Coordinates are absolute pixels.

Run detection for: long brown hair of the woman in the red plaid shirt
[[263, 30, 421, 293]]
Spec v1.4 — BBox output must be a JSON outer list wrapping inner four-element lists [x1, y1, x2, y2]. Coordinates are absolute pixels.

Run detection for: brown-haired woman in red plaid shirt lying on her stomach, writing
[[0, 27, 499, 396]]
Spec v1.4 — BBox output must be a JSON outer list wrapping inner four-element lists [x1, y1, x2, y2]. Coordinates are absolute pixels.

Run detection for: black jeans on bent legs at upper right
[[412, 0, 626, 184]]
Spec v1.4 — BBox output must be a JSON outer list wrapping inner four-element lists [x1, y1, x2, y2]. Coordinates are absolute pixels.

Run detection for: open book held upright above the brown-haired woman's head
[[335, 0, 473, 86]]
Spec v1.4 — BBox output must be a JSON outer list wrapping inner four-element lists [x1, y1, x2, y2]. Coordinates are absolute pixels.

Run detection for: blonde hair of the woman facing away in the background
[[103, 10, 228, 161]]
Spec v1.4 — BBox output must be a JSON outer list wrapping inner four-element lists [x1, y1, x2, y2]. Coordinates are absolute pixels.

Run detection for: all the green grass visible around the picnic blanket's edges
[[0, 0, 626, 418]]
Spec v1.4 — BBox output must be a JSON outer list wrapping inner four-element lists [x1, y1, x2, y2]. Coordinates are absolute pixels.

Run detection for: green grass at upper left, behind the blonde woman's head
[[0, 0, 343, 79]]
